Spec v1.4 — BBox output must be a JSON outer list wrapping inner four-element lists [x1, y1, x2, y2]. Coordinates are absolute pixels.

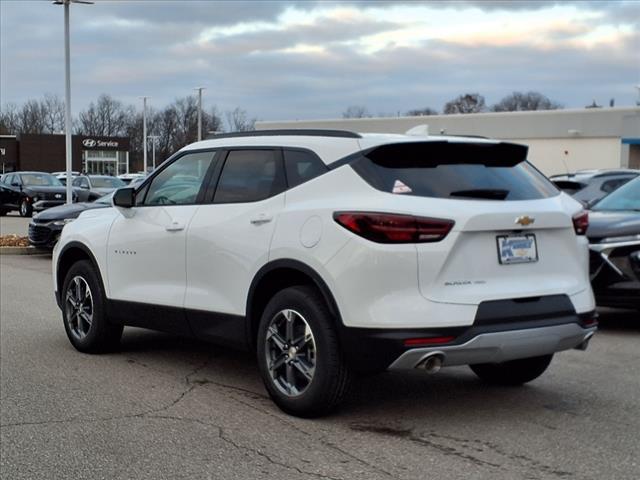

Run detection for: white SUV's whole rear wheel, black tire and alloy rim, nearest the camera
[[257, 286, 351, 417]]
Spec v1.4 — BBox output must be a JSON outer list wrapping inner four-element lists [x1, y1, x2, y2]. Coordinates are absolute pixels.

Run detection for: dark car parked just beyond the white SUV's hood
[[29, 195, 113, 248]]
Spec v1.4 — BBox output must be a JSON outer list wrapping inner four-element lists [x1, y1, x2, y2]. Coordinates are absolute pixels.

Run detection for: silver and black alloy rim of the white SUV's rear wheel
[[265, 309, 316, 397]]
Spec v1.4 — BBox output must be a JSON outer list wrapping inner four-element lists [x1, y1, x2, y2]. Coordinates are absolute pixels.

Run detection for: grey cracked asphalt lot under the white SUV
[[0, 253, 640, 480]]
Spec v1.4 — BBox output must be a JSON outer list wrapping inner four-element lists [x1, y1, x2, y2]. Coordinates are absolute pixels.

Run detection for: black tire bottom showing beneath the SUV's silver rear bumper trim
[[469, 355, 553, 385]]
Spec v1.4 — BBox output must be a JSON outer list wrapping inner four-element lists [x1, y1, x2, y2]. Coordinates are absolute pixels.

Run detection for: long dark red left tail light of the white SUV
[[333, 212, 454, 243]]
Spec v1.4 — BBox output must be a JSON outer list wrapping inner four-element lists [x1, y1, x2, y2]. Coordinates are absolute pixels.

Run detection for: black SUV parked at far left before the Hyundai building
[[0, 172, 79, 217]]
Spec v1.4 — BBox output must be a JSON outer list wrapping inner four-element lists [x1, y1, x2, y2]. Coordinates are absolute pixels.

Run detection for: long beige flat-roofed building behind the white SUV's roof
[[256, 107, 640, 175]]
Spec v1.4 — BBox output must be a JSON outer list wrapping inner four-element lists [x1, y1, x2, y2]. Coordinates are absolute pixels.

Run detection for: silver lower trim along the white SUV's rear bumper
[[389, 323, 596, 370]]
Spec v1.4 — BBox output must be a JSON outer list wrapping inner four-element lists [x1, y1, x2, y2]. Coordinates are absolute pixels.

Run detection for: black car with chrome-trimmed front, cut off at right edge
[[587, 178, 640, 310]]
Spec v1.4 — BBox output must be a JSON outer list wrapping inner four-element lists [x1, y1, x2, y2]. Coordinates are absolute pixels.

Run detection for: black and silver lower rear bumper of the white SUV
[[340, 295, 597, 372]]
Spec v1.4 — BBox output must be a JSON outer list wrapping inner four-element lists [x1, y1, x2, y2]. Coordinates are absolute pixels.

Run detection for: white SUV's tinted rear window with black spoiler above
[[351, 142, 559, 200]]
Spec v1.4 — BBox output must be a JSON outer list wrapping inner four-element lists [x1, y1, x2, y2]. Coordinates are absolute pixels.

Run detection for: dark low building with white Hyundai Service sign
[[0, 134, 129, 175]]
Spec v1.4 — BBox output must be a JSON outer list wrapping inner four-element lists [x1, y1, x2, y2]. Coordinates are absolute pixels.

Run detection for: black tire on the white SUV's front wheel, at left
[[62, 260, 123, 353]]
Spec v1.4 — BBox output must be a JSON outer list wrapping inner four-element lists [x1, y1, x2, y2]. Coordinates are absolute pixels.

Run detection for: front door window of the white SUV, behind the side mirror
[[140, 152, 214, 205]]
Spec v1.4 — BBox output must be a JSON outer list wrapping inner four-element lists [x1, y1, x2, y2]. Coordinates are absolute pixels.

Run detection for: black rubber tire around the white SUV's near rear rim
[[257, 286, 351, 418]]
